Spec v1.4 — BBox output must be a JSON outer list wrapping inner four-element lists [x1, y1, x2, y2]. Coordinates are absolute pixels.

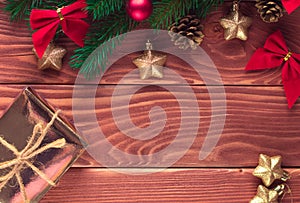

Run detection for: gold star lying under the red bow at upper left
[[32, 43, 67, 71]]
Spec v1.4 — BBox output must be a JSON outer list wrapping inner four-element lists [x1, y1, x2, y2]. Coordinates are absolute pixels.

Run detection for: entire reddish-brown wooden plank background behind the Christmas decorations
[[0, 1, 300, 203]]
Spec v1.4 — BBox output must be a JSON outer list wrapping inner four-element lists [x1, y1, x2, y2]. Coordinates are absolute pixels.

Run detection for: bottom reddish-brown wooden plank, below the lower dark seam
[[41, 168, 300, 203]]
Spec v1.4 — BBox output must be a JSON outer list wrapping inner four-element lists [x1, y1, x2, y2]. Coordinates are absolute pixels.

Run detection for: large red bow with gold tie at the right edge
[[246, 30, 300, 108]]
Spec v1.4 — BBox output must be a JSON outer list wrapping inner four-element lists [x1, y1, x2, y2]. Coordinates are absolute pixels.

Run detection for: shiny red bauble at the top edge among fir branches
[[126, 0, 153, 21]]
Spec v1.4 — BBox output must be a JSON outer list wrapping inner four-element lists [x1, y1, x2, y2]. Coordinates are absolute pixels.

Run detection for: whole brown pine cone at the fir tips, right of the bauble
[[169, 15, 204, 49]]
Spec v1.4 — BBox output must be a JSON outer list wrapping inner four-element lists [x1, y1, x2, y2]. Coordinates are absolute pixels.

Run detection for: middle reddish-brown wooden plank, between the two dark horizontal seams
[[0, 85, 300, 167]]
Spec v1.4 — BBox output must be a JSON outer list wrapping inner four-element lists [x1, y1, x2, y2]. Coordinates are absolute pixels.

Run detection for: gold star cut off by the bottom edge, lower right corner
[[250, 185, 279, 203]]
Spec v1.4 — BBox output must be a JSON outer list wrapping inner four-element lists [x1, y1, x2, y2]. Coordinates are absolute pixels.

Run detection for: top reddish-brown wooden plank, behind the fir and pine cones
[[0, 2, 300, 85]]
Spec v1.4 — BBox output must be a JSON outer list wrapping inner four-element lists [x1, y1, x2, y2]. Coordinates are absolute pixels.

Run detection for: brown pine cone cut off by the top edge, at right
[[255, 0, 284, 23]]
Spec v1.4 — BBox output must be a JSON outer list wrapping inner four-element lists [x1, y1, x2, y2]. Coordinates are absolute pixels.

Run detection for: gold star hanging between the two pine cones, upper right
[[220, 1, 252, 41]]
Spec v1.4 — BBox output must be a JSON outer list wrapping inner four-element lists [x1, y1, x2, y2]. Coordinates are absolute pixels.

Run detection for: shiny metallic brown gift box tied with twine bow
[[0, 88, 85, 203]]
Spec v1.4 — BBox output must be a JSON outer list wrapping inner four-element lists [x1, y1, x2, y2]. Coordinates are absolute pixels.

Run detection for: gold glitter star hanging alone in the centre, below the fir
[[132, 40, 167, 80]]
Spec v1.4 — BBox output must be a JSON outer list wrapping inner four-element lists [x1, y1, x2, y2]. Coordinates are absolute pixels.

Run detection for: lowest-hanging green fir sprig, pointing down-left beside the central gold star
[[70, 10, 138, 79]]
